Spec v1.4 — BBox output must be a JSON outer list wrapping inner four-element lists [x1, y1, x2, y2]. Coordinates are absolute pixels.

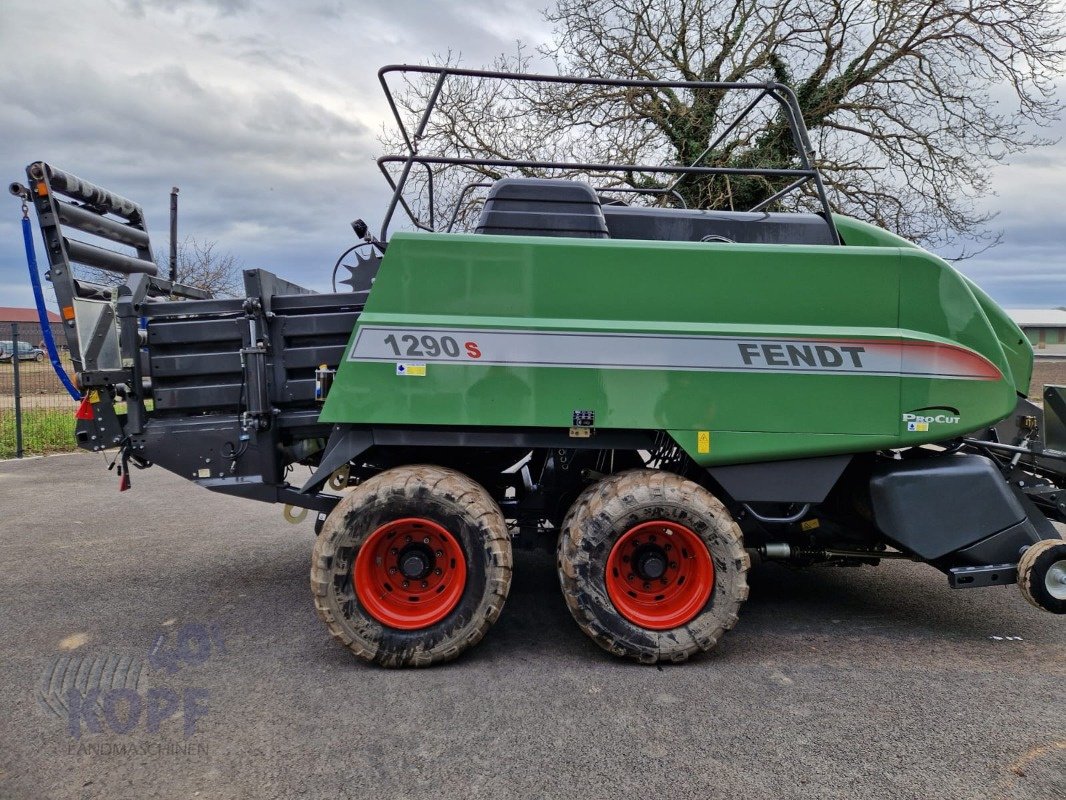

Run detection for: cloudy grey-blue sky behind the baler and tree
[[0, 0, 1066, 307]]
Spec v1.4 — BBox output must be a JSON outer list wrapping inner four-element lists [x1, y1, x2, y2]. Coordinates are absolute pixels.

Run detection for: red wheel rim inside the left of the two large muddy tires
[[352, 517, 466, 630]]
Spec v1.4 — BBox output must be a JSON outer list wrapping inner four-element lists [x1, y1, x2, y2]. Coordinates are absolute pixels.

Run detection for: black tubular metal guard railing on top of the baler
[[377, 64, 840, 244]]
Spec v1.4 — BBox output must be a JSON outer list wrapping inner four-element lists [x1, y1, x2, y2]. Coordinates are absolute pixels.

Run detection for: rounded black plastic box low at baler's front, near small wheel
[[870, 453, 1027, 561]]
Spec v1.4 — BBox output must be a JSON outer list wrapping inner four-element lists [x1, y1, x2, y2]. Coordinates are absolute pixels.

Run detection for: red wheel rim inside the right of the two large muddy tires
[[607, 519, 714, 630]]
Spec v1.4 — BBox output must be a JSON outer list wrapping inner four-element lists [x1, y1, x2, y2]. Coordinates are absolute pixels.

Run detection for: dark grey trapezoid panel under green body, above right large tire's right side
[[707, 455, 852, 502]]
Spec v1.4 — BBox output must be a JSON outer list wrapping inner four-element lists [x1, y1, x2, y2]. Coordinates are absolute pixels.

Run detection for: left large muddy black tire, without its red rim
[[311, 465, 512, 667]]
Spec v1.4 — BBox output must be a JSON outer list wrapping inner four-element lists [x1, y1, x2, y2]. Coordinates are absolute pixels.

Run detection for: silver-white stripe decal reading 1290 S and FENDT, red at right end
[[349, 325, 1001, 381]]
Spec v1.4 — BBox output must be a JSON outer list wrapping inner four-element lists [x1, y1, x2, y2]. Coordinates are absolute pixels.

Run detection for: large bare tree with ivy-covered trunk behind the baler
[[383, 0, 1064, 254]]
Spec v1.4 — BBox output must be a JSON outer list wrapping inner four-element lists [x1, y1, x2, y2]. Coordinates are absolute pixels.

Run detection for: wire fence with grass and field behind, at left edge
[[0, 322, 78, 459]]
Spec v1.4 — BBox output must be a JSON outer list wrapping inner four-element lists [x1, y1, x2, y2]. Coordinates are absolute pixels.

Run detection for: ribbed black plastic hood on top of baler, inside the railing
[[475, 178, 609, 239]]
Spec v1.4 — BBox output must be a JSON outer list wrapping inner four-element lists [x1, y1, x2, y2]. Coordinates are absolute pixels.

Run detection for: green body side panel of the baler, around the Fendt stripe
[[321, 223, 1031, 464]]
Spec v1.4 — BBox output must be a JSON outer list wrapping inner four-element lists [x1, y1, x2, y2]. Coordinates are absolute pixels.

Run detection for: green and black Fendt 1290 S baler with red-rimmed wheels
[[13, 67, 1066, 666]]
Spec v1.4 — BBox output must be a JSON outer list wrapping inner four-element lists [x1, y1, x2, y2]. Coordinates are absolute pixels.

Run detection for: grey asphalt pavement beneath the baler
[[0, 454, 1066, 800]]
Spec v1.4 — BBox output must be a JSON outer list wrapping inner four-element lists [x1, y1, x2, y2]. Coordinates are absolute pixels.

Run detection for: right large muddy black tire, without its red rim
[[558, 469, 750, 663]]
